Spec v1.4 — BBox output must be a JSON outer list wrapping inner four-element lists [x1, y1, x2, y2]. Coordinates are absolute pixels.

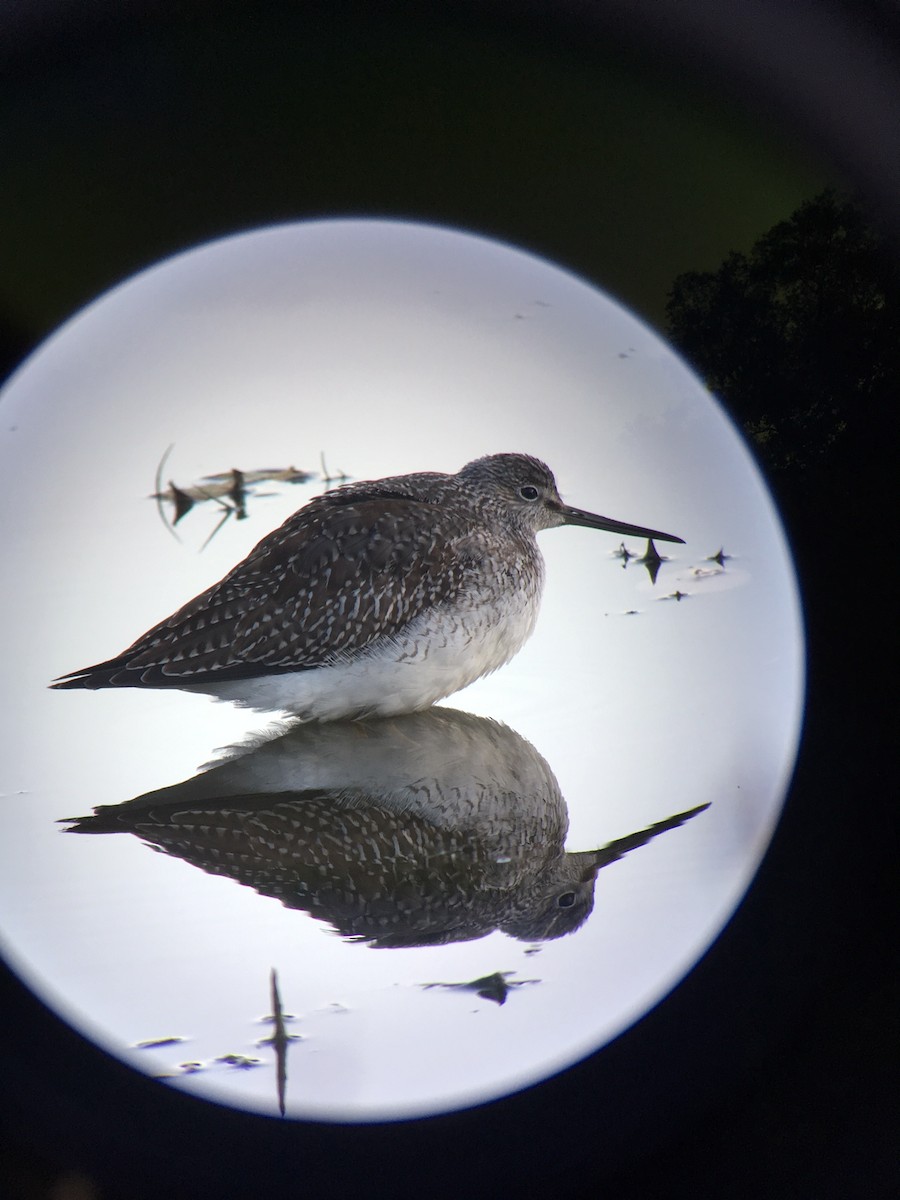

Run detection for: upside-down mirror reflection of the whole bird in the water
[[68, 708, 708, 948]]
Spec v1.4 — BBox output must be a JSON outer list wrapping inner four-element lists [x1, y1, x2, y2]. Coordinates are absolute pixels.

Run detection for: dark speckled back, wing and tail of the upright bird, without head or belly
[[55, 474, 541, 688]]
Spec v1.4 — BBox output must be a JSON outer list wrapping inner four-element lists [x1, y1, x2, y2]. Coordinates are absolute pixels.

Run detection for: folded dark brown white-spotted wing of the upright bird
[[58, 492, 478, 688]]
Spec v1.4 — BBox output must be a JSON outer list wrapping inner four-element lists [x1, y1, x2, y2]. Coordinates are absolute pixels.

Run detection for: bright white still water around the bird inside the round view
[[0, 221, 803, 1120]]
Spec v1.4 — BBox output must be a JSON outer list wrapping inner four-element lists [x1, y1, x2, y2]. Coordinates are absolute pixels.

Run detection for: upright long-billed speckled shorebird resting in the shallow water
[[53, 454, 683, 721]]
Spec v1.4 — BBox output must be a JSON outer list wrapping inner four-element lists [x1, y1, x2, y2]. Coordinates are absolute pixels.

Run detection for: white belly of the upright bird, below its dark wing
[[186, 596, 538, 721]]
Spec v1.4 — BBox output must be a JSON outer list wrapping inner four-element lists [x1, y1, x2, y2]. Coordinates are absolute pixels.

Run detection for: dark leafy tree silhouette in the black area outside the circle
[[666, 191, 900, 508]]
